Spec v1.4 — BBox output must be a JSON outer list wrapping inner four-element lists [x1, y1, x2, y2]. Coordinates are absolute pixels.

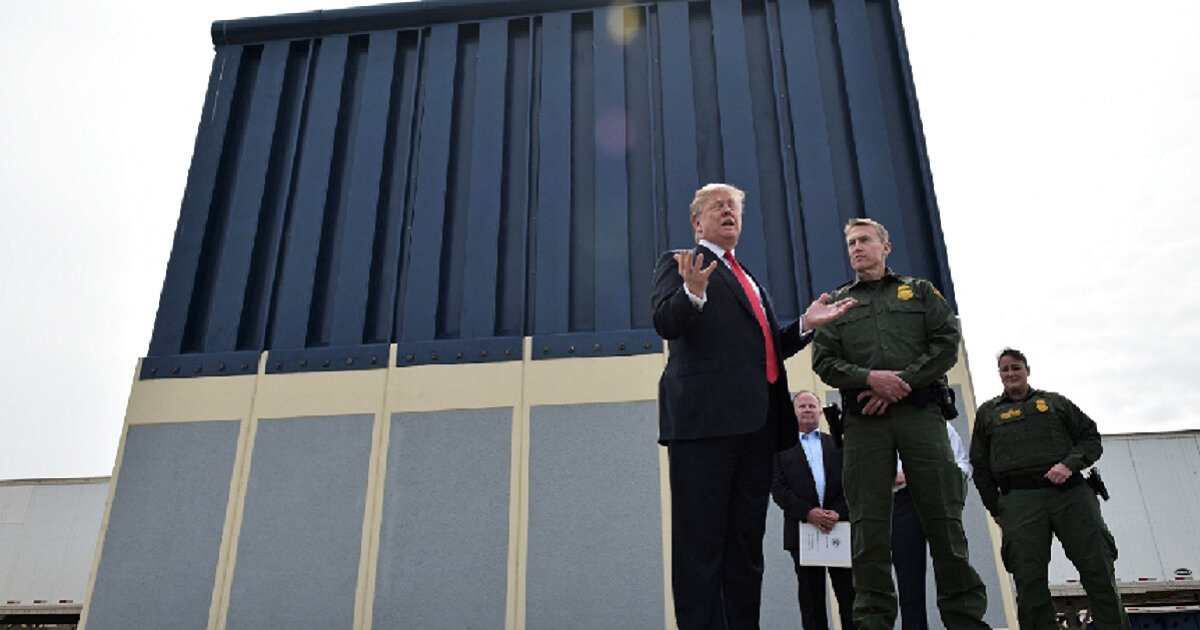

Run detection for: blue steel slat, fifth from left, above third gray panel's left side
[[400, 24, 458, 341]]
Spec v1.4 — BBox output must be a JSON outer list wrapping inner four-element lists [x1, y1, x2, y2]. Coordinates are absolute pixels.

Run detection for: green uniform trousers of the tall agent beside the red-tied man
[[842, 404, 988, 630]]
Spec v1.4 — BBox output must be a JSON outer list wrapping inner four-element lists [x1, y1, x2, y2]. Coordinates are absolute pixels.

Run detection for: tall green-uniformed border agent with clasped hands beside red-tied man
[[812, 218, 988, 630]]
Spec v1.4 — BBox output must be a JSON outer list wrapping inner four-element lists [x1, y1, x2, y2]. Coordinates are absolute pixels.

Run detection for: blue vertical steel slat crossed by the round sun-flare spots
[[593, 6, 630, 330]]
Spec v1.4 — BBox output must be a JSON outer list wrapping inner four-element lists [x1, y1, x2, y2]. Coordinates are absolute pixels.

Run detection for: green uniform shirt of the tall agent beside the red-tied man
[[812, 269, 960, 389]]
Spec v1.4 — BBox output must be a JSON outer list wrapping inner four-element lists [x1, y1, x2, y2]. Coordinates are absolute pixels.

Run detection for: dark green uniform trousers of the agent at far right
[[998, 480, 1129, 630]]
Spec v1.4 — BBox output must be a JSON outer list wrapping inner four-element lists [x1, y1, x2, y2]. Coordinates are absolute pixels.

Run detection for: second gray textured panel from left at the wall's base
[[227, 415, 374, 630]]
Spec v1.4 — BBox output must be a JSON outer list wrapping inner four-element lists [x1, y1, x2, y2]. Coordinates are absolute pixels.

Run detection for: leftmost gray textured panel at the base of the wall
[[88, 421, 239, 630]]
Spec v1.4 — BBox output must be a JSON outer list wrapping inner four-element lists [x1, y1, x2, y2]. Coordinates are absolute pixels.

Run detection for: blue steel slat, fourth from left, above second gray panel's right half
[[329, 31, 396, 346]]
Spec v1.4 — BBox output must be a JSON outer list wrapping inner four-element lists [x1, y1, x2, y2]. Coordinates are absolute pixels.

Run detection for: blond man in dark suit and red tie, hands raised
[[650, 184, 854, 630]]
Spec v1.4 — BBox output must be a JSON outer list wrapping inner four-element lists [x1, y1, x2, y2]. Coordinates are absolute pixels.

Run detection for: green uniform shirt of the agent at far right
[[971, 389, 1103, 514]]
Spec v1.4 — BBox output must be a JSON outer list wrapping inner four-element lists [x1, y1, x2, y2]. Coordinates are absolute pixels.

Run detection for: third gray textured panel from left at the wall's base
[[372, 408, 512, 630]]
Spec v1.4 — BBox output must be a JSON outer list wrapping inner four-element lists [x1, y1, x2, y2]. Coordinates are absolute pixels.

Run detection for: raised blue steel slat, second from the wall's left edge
[[204, 42, 289, 352]]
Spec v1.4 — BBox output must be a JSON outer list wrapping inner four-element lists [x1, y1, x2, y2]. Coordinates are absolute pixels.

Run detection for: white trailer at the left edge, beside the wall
[[0, 476, 109, 624]]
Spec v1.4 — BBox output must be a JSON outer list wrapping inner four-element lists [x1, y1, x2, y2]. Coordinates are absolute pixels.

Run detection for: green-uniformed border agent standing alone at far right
[[971, 348, 1129, 630]]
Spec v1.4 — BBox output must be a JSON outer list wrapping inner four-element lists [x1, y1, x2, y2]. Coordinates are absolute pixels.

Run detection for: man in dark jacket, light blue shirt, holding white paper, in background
[[770, 390, 854, 630]]
